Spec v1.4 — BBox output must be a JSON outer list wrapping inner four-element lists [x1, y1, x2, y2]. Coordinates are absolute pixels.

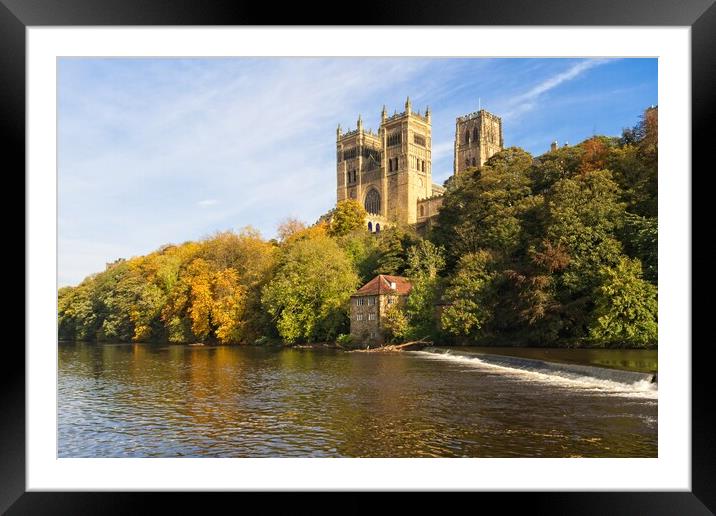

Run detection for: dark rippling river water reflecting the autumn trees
[[58, 343, 657, 457]]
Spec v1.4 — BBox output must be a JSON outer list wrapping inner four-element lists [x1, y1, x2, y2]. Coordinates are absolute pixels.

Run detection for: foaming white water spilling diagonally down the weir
[[413, 351, 659, 400]]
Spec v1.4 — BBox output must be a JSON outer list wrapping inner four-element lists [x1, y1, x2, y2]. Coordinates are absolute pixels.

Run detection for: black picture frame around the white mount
[[0, 0, 716, 515]]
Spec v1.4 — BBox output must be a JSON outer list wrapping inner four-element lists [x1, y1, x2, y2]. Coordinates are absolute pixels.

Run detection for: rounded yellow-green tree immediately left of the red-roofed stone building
[[261, 235, 358, 343]]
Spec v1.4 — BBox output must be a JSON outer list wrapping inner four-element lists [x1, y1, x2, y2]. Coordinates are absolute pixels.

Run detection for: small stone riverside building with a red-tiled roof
[[350, 274, 412, 344]]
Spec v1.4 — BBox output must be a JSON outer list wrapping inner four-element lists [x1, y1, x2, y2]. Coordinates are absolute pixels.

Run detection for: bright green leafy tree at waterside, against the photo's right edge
[[589, 258, 658, 347]]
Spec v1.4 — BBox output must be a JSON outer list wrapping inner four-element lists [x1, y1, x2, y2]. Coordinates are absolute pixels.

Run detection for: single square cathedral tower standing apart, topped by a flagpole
[[453, 109, 504, 174]]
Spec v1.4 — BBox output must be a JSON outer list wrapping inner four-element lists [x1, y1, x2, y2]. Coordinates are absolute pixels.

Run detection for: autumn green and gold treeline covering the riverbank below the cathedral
[[58, 110, 658, 347]]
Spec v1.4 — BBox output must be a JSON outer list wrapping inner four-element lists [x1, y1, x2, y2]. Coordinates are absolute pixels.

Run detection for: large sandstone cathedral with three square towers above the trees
[[336, 98, 504, 232]]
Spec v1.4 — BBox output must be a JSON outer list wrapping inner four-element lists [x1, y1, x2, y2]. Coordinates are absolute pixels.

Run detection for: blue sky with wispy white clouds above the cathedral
[[57, 58, 658, 286]]
